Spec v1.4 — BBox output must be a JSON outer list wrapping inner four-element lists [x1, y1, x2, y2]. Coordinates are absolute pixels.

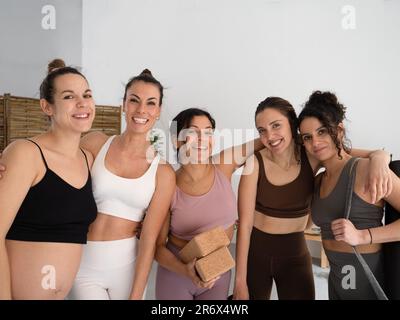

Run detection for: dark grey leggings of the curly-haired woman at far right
[[325, 250, 383, 300]]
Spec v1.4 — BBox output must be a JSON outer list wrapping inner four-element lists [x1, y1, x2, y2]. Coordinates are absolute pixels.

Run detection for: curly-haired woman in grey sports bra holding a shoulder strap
[[299, 91, 400, 300]]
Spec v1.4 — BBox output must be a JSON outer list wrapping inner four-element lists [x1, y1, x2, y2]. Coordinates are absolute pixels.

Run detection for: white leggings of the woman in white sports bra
[[68, 237, 138, 300]]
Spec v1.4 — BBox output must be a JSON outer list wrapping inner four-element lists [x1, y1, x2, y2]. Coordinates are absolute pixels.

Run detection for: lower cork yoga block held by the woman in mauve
[[195, 247, 235, 281]]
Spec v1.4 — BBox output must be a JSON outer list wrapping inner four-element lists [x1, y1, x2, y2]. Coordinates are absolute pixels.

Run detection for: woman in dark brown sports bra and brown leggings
[[234, 97, 387, 299]]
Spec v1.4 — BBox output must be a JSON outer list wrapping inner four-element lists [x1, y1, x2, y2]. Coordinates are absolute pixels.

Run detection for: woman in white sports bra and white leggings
[[69, 69, 175, 300]]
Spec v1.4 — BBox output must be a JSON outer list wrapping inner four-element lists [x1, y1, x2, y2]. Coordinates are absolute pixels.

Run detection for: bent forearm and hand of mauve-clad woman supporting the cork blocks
[[155, 213, 219, 288]]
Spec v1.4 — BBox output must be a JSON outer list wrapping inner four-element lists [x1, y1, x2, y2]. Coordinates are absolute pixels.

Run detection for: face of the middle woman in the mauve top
[[178, 116, 214, 164]]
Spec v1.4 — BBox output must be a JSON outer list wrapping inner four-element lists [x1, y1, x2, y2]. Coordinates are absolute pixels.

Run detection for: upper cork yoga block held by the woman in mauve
[[179, 227, 230, 263]]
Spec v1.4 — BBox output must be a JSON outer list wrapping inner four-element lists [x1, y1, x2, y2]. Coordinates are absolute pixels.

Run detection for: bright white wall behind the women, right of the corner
[[83, 0, 400, 158]]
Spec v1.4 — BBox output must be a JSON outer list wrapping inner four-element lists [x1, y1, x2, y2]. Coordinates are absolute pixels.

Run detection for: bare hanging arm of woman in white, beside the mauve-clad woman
[[130, 164, 175, 300]]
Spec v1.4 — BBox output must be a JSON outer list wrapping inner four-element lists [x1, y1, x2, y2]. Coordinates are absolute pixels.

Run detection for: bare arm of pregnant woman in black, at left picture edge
[[0, 140, 37, 300]]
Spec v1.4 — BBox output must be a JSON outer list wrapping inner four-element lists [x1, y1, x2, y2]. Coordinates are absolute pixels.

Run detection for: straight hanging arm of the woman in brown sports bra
[[233, 156, 259, 300]]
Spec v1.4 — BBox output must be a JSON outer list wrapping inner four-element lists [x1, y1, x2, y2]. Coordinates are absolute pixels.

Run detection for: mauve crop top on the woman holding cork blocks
[[170, 166, 237, 240]]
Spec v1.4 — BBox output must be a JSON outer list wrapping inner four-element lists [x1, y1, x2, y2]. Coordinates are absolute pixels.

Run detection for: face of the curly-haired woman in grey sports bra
[[300, 117, 343, 161]]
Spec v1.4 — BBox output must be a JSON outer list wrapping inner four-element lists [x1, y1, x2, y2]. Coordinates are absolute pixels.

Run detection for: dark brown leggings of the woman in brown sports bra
[[247, 227, 315, 300]]
